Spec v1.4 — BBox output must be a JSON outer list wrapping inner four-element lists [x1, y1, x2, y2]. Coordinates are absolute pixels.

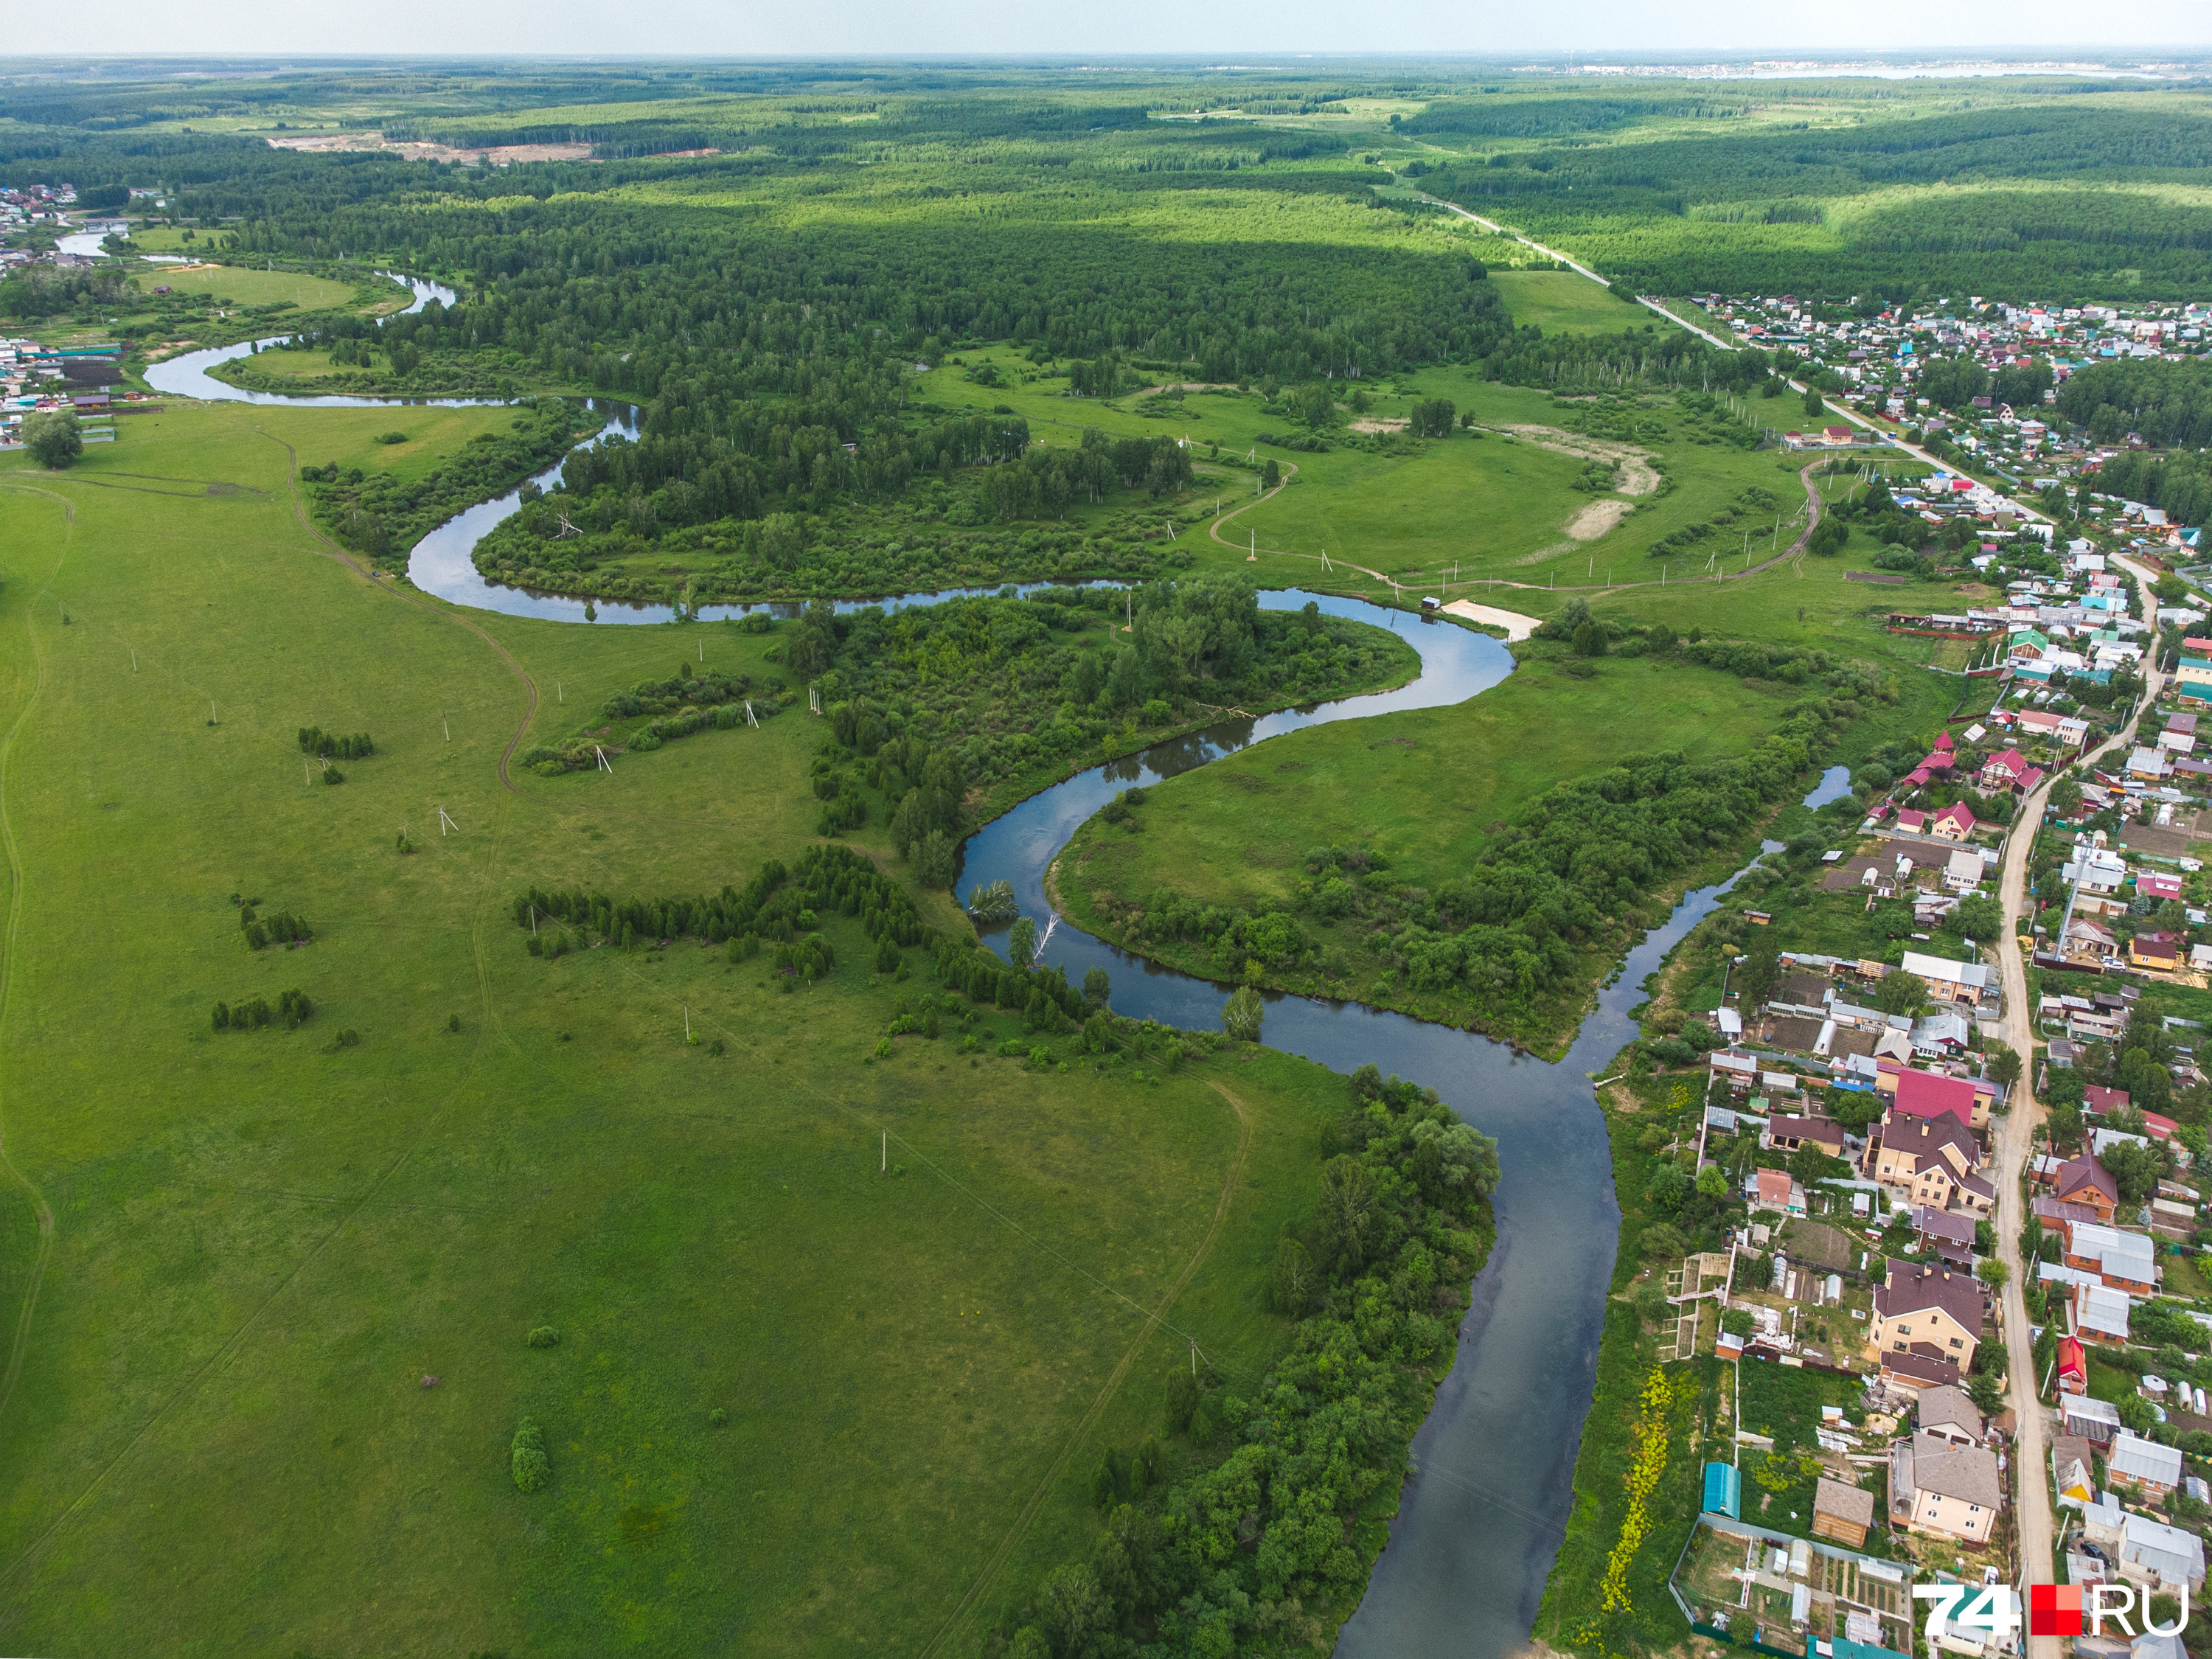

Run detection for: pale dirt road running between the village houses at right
[[1995, 560, 2166, 1659]]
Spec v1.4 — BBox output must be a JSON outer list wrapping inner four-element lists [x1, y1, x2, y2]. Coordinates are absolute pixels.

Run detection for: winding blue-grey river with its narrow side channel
[[146, 314, 1847, 1659]]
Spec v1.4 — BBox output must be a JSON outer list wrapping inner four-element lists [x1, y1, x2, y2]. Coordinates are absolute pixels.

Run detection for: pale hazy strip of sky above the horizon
[[0, 0, 2212, 62]]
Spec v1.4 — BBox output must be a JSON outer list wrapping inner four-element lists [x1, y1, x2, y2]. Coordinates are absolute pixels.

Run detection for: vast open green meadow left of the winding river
[[0, 407, 1343, 1655]]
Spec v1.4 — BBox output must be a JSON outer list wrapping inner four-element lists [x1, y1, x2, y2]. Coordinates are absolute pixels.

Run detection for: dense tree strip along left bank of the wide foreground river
[[1013, 1066, 1498, 1657]]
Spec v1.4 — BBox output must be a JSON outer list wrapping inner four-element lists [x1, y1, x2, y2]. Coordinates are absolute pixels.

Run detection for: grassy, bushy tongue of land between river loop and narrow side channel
[[1051, 648, 1858, 1060]]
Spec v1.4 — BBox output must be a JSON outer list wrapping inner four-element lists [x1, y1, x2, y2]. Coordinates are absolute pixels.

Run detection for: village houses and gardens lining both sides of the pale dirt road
[[1644, 584, 2212, 1659]]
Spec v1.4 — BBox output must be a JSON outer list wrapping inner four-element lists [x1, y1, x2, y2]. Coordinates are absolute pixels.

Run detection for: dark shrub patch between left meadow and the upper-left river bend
[[299, 398, 595, 564]]
